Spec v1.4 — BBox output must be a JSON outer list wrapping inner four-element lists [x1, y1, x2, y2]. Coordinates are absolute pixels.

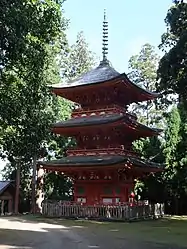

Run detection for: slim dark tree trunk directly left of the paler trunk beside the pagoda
[[31, 155, 37, 214]]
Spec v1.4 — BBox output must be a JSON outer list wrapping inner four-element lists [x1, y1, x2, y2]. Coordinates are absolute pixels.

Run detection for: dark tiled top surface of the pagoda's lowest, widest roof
[[38, 155, 163, 168]]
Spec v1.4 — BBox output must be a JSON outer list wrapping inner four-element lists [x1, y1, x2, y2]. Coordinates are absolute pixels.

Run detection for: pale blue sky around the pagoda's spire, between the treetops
[[64, 0, 172, 73]]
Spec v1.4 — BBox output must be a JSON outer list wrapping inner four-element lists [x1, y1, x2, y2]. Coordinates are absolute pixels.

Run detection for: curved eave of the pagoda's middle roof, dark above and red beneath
[[52, 115, 162, 135]]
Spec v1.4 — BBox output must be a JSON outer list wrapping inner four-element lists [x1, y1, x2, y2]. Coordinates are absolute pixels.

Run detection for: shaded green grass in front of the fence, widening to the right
[[31, 216, 187, 248]]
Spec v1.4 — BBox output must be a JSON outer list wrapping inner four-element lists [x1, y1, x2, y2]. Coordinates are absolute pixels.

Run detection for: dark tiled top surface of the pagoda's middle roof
[[53, 113, 162, 133]]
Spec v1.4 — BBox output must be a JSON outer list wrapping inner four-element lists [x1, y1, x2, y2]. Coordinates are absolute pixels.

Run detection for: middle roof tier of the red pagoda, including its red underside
[[52, 113, 162, 138]]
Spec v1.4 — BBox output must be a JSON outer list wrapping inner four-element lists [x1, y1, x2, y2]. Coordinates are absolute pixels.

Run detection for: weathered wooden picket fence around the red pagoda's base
[[42, 202, 164, 221]]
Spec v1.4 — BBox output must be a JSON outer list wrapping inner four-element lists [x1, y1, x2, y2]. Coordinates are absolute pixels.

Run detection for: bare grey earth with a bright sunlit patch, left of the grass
[[0, 217, 186, 249]]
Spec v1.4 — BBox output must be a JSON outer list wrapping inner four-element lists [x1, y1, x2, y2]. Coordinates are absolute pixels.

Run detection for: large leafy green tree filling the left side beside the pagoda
[[0, 0, 66, 213]]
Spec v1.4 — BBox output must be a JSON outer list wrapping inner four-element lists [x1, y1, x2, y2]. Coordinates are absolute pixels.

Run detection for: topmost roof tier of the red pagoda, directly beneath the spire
[[52, 61, 159, 106]]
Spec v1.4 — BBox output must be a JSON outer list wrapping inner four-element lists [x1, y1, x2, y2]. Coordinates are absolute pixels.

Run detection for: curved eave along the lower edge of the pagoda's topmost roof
[[51, 73, 161, 101]]
